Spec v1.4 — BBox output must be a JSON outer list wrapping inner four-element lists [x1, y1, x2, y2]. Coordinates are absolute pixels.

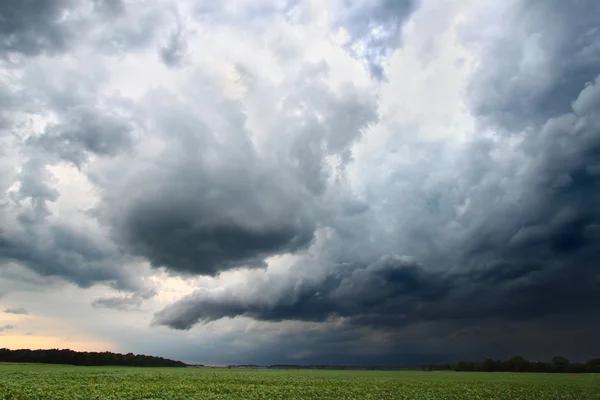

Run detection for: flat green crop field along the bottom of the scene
[[0, 364, 600, 400]]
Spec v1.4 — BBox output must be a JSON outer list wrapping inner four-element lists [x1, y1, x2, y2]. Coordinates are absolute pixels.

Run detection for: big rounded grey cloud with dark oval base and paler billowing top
[[100, 67, 376, 275]]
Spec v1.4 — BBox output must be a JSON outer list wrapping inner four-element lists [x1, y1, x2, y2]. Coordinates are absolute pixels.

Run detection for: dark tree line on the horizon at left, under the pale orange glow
[[0, 349, 186, 367]]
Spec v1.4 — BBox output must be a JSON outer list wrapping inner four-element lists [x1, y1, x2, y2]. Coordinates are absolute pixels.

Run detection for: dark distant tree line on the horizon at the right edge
[[421, 355, 600, 373]]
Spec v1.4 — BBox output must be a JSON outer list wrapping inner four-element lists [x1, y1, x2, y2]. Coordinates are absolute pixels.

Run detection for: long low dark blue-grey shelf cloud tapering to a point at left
[[154, 198, 600, 329]]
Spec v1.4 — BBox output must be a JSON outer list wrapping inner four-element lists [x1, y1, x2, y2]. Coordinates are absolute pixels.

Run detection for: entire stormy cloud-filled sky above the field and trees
[[0, 0, 600, 365]]
